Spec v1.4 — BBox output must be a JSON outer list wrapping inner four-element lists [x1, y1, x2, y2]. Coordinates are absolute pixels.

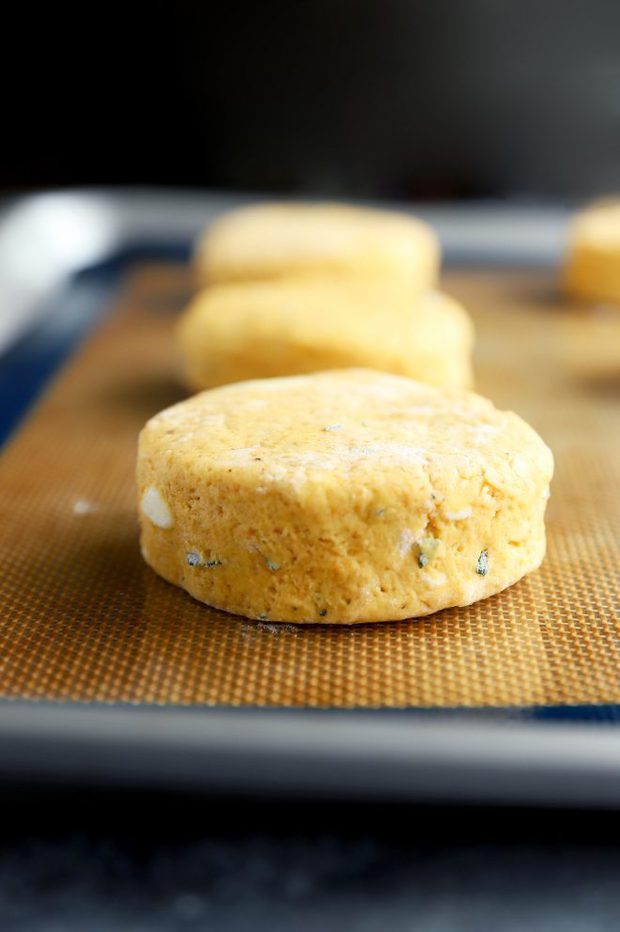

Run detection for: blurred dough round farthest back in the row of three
[[195, 203, 439, 291]]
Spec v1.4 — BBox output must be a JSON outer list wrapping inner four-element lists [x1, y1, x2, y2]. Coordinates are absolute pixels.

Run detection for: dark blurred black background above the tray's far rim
[[0, 0, 620, 200]]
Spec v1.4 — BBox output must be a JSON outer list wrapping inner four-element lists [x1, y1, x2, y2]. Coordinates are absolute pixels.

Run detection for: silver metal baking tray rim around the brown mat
[[0, 189, 620, 806]]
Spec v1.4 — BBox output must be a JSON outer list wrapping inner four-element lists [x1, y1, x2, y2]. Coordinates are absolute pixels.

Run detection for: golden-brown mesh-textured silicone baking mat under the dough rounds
[[0, 263, 620, 707]]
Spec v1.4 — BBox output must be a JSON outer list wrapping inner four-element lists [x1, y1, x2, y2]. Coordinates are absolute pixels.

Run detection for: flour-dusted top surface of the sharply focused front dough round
[[141, 369, 553, 494]]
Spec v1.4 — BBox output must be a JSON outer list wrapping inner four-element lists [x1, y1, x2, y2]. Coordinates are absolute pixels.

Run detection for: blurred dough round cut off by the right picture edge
[[564, 201, 620, 303]]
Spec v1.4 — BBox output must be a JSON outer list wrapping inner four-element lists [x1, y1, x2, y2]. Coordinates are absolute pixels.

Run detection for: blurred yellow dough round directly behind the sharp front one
[[177, 279, 473, 391]]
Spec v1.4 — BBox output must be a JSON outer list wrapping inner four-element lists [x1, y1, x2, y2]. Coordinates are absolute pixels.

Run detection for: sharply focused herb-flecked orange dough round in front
[[138, 369, 553, 624]]
